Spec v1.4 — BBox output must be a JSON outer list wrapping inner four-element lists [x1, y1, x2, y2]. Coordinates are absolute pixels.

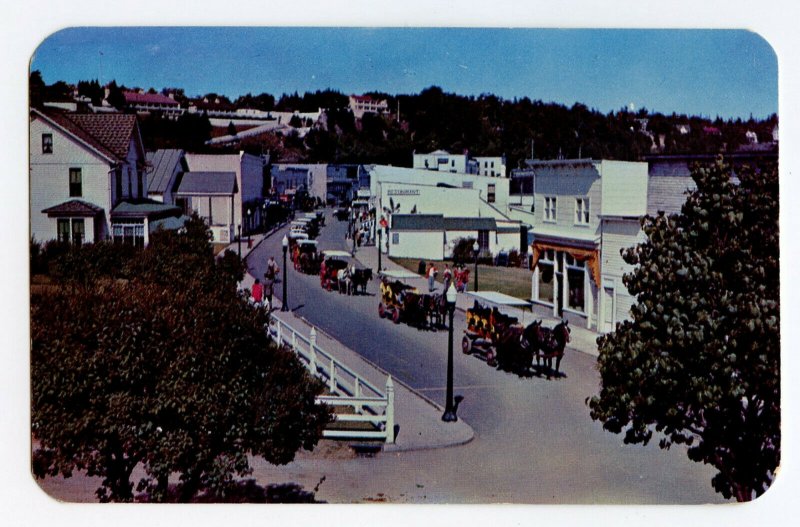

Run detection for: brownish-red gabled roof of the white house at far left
[[31, 108, 141, 162]]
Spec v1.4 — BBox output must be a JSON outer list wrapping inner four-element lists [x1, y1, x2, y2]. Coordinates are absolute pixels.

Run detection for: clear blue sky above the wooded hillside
[[31, 27, 778, 118]]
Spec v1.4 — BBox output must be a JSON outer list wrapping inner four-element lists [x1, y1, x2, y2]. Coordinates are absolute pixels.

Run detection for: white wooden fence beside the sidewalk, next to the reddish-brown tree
[[268, 317, 395, 444]]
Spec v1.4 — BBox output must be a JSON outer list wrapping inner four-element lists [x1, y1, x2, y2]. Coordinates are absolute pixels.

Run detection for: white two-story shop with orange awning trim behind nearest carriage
[[511, 159, 648, 332]]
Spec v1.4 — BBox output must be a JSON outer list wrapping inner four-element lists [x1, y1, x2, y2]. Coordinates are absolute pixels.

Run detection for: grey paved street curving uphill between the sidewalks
[[248, 211, 722, 504]]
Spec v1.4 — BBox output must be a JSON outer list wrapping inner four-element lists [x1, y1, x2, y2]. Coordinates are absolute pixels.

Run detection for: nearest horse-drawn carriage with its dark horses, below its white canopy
[[461, 300, 570, 379]]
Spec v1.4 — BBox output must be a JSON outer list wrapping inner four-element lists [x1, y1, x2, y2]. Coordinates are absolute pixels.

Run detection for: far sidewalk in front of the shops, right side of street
[[355, 239, 599, 357]]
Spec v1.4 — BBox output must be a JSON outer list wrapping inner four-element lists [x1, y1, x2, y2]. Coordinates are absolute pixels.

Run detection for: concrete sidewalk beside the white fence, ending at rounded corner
[[225, 219, 475, 452]]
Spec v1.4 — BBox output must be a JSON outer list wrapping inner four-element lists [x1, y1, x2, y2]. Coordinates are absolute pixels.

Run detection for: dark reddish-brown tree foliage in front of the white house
[[31, 218, 330, 501]]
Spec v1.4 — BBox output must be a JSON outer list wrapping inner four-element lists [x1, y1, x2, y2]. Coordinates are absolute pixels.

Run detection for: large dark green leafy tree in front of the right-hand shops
[[589, 160, 781, 501]]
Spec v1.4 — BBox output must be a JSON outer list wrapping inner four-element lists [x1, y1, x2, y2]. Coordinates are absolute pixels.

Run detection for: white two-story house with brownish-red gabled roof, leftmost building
[[29, 109, 180, 246]]
